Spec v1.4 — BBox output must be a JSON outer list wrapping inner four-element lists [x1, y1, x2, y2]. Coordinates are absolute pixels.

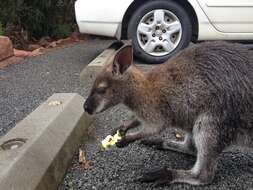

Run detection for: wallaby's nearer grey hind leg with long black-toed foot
[[140, 115, 227, 185]]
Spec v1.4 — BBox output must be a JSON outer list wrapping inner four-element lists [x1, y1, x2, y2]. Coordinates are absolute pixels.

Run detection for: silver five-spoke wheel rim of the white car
[[137, 9, 182, 56]]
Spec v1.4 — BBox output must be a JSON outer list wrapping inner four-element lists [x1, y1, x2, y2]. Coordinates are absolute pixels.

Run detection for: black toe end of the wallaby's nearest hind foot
[[138, 167, 173, 185]]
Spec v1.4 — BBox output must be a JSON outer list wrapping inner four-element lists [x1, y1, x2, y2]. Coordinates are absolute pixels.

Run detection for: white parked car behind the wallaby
[[75, 0, 253, 63]]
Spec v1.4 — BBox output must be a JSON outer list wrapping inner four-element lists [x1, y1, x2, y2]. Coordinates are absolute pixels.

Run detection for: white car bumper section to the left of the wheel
[[75, 0, 133, 37]]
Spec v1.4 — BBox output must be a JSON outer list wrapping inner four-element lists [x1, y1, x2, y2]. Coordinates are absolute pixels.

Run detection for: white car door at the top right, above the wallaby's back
[[197, 0, 253, 33]]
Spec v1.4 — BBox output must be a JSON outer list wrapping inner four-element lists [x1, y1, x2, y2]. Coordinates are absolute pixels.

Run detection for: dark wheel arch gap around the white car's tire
[[121, 0, 199, 42]]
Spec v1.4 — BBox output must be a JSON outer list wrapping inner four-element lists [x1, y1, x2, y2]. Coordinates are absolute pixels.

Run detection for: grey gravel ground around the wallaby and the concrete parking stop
[[0, 40, 253, 190]]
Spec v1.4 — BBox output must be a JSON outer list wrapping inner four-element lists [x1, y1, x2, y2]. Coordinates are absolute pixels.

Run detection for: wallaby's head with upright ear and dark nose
[[84, 46, 133, 114]]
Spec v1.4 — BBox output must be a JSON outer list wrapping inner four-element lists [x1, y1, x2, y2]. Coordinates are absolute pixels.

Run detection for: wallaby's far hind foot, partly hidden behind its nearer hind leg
[[141, 133, 196, 156]]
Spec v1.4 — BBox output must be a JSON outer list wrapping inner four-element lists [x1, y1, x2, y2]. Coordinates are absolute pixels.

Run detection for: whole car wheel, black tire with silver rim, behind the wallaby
[[127, 0, 192, 64]]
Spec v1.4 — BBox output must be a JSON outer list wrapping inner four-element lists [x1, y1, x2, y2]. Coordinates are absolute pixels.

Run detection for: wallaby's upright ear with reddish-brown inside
[[112, 45, 133, 75]]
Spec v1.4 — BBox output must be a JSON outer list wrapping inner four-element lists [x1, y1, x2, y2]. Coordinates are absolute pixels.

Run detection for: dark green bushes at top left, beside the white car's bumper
[[0, 0, 75, 39]]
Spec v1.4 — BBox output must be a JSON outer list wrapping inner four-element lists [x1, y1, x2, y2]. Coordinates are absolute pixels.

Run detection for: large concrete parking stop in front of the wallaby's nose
[[0, 94, 93, 190]]
